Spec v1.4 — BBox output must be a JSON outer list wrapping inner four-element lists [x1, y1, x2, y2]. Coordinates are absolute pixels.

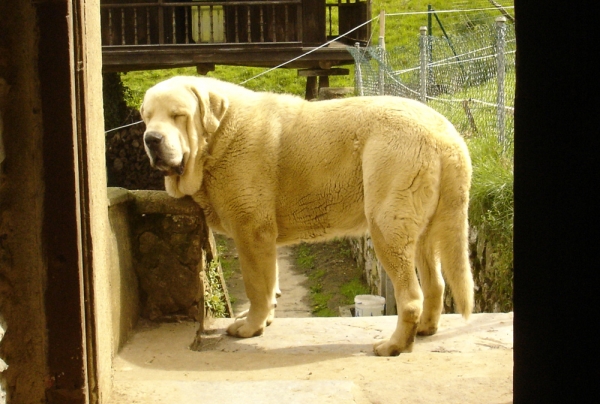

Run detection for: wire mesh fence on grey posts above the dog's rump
[[349, 12, 516, 146]]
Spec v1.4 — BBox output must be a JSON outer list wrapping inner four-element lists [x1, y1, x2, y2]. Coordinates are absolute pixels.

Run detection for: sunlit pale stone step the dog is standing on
[[110, 313, 513, 404]]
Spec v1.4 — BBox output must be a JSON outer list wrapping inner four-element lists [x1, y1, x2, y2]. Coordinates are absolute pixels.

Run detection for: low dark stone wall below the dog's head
[[109, 188, 231, 323]]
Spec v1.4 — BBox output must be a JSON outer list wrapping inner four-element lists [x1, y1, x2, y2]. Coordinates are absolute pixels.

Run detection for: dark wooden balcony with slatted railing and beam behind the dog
[[101, 0, 371, 72]]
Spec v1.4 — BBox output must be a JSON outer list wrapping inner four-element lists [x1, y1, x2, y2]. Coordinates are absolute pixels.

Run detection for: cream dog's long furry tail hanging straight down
[[424, 139, 474, 318]]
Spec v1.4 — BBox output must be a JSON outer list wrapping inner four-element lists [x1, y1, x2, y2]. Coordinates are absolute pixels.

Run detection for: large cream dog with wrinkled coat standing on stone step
[[141, 77, 473, 356]]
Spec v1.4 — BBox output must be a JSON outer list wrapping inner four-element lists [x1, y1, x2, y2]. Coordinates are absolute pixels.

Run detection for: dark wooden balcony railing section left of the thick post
[[101, 0, 303, 47]]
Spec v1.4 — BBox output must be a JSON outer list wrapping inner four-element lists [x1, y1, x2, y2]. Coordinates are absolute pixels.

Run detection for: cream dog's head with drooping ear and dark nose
[[140, 77, 229, 197]]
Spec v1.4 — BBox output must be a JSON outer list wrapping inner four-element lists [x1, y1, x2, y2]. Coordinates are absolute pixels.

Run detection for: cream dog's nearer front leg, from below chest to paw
[[227, 228, 277, 338]]
